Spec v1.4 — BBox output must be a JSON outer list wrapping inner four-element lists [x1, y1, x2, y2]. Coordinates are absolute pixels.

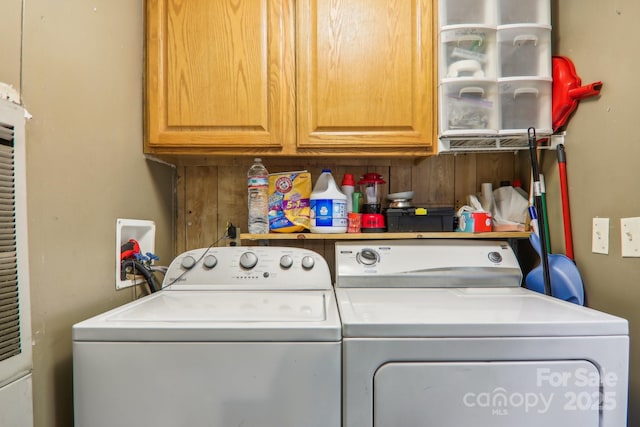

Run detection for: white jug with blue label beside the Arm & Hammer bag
[[309, 169, 347, 233]]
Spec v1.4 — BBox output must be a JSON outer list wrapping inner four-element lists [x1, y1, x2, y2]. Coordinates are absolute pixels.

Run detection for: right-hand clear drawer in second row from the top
[[497, 24, 551, 78]]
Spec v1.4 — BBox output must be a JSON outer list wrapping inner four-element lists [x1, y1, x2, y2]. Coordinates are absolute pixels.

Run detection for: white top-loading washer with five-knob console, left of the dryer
[[73, 247, 341, 427]]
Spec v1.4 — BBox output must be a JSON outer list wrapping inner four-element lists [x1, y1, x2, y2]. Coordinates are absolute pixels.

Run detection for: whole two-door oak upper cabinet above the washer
[[145, 0, 437, 156]]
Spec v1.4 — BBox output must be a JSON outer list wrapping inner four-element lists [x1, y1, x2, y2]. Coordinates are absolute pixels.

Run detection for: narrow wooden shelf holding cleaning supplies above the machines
[[240, 231, 529, 240]]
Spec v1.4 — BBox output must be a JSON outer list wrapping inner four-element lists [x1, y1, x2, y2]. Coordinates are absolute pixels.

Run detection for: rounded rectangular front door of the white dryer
[[374, 361, 604, 427]]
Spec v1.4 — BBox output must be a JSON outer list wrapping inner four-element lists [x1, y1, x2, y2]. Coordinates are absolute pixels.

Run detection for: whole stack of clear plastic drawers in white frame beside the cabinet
[[438, 0, 553, 141]]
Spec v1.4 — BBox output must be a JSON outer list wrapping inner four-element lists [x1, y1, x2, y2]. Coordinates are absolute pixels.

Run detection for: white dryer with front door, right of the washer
[[335, 239, 629, 427]]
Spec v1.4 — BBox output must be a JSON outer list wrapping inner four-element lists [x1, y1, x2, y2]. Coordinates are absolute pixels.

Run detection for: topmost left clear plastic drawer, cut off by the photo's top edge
[[439, 0, 497, 27]]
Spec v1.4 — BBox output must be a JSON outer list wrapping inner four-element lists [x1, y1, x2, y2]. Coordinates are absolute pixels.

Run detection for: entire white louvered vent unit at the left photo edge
[[0, 96, 33, 427]]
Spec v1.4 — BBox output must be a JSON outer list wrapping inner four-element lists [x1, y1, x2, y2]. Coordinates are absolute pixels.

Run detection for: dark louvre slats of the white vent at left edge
[[0, 123, 21, 361]]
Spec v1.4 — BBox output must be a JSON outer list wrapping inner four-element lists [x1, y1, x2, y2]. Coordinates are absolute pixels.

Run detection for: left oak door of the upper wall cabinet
[[145, 0, 295, 154]]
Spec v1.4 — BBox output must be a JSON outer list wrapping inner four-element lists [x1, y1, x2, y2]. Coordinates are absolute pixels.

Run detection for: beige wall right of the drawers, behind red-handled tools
[[544, 0, 640, 426]]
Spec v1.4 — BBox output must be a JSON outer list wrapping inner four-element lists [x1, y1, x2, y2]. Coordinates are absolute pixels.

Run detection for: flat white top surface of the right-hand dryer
[[336, 288, 629, 338]]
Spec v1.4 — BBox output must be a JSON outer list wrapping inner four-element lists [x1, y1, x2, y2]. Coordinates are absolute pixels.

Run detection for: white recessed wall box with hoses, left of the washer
[[116, 218, 156, 289]]
